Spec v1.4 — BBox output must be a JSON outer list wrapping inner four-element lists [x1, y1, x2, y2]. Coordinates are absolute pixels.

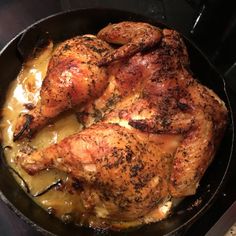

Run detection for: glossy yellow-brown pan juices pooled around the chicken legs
[[0, 40, 172, 229]]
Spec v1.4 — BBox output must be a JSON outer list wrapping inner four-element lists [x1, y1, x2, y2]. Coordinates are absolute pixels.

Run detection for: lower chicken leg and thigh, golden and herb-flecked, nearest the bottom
[[22, 123, 177, 221]]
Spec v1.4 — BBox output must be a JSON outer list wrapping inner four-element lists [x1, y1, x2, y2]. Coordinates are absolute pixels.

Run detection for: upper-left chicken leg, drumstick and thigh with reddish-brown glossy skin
[[14, 35, 111, 140]]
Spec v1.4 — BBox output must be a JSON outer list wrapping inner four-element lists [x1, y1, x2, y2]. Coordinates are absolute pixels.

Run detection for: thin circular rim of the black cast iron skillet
[[0, 7, 235, 235]]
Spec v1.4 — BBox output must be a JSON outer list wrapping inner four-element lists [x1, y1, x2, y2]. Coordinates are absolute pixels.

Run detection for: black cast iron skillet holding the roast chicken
[[0, 9, 234, 236]]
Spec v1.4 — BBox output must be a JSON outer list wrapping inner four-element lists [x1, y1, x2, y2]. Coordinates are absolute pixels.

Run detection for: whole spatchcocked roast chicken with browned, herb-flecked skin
[[15, 22, 227, 229]]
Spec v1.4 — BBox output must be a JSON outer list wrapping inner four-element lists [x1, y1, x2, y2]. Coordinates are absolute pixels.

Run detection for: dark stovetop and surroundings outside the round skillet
[[0, 0, 236, 236]]
